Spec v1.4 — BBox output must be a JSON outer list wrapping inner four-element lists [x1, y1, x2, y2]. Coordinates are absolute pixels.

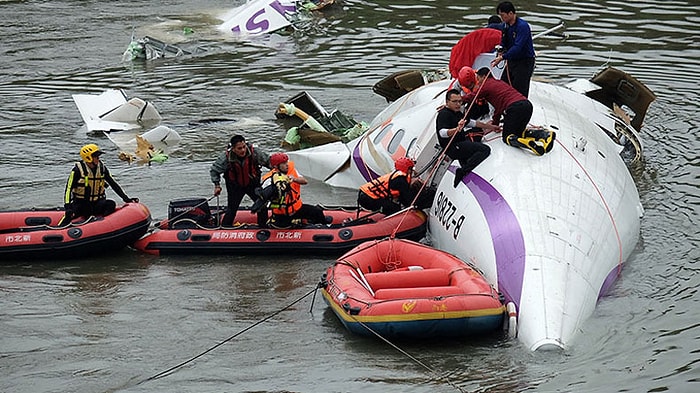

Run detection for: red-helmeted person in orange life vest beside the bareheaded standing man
[[263, 153, 326, 228]]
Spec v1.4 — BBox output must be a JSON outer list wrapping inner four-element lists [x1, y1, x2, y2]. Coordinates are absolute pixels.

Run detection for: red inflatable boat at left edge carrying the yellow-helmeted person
[[0, 203, 151, 261]]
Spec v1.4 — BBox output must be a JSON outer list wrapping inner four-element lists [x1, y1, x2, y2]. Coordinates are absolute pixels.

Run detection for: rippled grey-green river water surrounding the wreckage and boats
[[0, 0, 700, 392]]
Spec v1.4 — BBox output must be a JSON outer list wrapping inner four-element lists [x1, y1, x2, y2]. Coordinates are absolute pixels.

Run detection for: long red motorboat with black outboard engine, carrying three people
[[134, 199, 426, 255]]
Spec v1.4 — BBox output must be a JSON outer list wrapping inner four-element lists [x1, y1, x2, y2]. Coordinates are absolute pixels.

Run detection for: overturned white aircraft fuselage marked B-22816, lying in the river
[[290, 73, 643, 350]]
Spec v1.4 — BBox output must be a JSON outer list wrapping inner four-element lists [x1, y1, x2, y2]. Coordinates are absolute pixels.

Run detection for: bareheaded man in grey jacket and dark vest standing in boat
[[209, 135, 269, 227]]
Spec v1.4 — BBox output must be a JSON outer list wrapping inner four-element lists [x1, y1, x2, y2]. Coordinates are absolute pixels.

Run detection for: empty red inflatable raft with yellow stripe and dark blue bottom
[[321, 239, 505, 339]]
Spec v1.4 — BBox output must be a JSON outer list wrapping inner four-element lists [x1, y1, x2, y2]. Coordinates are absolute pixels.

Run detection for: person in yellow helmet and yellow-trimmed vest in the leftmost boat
[[58, 143, 139, 227]]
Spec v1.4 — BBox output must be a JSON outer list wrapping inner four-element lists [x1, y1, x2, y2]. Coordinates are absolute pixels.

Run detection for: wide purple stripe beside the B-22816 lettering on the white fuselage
[[450, 167, 525, 309]]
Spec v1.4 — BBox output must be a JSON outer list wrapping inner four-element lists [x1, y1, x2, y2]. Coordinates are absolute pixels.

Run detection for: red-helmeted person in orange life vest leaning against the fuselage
[[357, 157, 415, 216]]
